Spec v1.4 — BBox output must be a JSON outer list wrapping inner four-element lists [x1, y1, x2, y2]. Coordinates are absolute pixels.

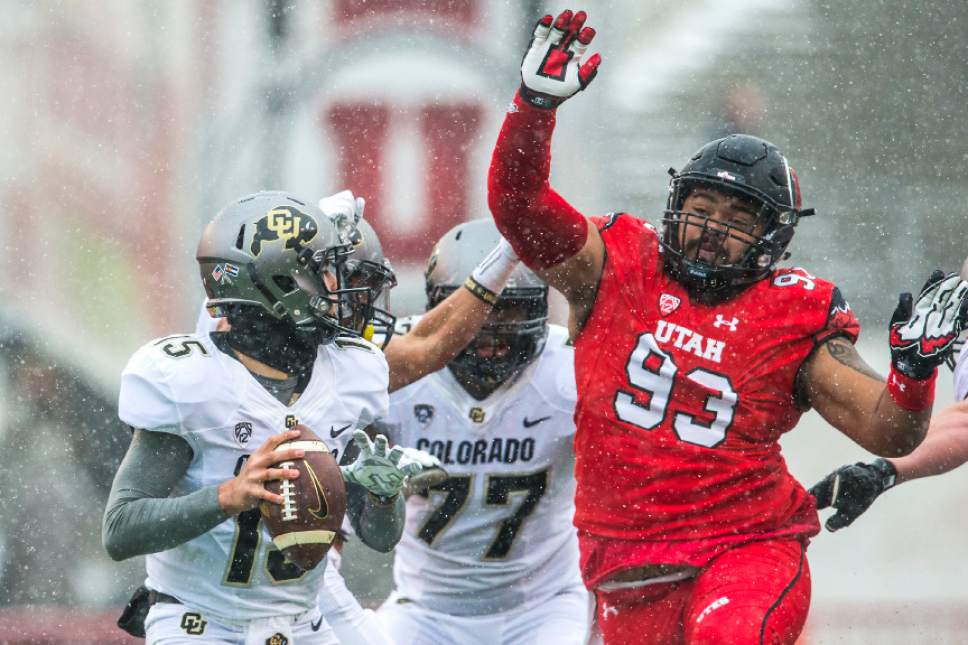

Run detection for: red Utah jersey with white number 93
[[575, 215, 860, 587]]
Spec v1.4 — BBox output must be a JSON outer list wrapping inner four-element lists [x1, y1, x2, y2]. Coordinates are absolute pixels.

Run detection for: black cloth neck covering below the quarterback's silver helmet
[[226, 307, 322, 377]]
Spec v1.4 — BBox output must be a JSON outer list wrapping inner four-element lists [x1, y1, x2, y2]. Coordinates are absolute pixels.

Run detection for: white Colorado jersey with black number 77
[[385, 321, 580, 616]]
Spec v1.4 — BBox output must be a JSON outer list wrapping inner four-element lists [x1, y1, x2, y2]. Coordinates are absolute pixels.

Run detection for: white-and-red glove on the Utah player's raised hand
[[520, 10, 602, 108]]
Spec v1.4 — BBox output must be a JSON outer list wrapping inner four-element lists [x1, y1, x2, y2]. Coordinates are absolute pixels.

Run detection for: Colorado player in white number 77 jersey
[[378, 218, 588, 645]]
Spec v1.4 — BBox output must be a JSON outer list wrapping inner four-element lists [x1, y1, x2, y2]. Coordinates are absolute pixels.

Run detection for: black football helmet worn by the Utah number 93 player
[[662, 134, 813, 295]]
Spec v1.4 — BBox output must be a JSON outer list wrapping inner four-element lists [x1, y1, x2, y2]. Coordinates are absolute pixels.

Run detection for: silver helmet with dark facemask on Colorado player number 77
[[425, 218, 548, 390]]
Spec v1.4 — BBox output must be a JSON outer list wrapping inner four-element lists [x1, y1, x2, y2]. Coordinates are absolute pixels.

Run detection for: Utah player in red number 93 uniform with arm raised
[[488, 11, 968, 644]]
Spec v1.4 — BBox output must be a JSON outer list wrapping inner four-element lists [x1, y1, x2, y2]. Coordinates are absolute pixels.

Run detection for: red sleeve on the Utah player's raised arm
[[487, 95, 588, 269]]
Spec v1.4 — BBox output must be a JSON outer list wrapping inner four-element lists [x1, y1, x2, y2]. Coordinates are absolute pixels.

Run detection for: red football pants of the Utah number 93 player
[[596, 540, 810, 645]]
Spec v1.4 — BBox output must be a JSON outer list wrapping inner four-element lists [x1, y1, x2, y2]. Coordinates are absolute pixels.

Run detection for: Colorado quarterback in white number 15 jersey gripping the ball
[[104, 192, 510, 643]]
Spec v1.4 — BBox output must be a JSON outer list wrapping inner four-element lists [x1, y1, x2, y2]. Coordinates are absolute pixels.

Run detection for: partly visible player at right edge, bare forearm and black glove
[[810, 259, 968, 531]]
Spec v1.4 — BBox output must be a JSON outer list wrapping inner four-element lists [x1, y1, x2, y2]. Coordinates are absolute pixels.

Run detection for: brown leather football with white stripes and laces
[[259, 425, 346, 570]]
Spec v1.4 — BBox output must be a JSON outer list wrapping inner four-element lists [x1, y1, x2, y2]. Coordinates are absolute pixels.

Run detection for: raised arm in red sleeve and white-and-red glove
[[488, 11, 604, 315]]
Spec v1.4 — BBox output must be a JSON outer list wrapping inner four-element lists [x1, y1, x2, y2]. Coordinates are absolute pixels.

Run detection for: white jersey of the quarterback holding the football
[[118, 334, 388, 621]]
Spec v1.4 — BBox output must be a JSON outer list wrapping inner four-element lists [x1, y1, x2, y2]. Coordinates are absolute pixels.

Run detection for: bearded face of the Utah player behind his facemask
[[678, 188, 763, 266]]
